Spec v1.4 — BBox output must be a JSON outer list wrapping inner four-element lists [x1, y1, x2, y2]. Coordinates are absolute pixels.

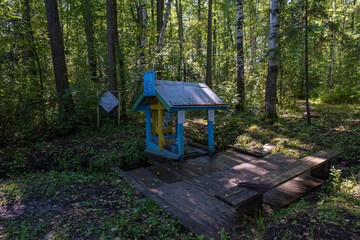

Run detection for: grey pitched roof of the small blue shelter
[[132, 80, 227, 111]]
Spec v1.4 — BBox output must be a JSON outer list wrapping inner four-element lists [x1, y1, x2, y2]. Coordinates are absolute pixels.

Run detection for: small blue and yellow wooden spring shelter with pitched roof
[[132, 71, 227, 160]]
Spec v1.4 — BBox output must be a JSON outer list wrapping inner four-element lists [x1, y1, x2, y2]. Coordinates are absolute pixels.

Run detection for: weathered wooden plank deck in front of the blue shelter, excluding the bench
[[122, 151, 323, 238]]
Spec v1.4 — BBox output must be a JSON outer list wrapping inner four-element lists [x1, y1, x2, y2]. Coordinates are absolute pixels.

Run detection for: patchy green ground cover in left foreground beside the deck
[[0, 172, 191, 239]]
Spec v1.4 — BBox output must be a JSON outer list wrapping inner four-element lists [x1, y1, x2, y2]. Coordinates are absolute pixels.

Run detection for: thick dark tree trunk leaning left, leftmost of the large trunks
[[45, 0, 69, 94]]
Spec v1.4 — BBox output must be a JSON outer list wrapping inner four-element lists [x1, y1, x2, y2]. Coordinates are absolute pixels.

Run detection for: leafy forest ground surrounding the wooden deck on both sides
[[0, 103, 360, 239]]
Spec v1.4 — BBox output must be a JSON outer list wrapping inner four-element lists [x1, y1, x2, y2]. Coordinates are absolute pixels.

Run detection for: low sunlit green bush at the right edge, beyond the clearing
[[319, 86, 360, 104]]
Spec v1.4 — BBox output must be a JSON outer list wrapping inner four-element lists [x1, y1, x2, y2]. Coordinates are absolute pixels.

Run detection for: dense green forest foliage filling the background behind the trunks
[[0, 0, 360, 145]]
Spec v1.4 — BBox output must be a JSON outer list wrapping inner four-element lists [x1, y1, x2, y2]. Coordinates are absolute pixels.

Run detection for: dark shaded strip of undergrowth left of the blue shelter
[[0, 125, 148, 177]]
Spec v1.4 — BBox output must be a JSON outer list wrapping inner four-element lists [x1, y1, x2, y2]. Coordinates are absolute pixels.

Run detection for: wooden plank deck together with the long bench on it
[[115, 151, 339, 238]]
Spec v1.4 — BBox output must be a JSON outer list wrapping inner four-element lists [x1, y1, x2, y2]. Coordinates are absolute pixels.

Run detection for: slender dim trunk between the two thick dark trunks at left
[[82, 0, 97, 81]]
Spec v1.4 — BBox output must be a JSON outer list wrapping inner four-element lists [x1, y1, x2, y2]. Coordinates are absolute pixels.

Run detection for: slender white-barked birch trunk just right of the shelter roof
[[236, 0, 245, 111]]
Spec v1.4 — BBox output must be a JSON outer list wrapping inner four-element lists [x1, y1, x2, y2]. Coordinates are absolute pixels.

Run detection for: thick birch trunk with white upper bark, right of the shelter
[[264, 0, 280, 122]]
